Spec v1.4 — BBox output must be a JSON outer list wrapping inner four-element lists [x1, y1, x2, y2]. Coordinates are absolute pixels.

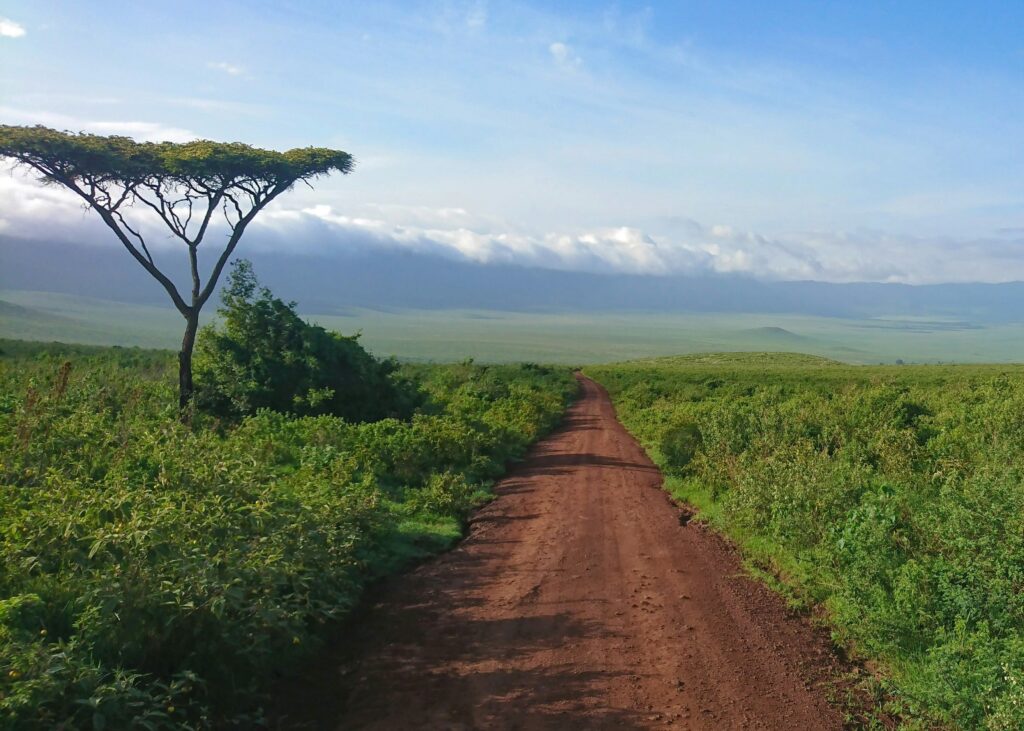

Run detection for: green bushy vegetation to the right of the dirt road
[[587, 353, 1024, 730]]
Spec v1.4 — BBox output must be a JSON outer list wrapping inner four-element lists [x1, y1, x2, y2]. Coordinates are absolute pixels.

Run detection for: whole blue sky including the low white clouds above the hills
[[0, 0, 1024, 282]]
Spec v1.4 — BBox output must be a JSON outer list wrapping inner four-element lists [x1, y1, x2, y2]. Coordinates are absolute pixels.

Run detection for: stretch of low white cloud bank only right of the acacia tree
[[245, 204, 1024, 284]]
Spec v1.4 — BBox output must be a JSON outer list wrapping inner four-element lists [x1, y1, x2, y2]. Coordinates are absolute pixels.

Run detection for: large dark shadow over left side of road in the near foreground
[[270, 528, 649, 731]]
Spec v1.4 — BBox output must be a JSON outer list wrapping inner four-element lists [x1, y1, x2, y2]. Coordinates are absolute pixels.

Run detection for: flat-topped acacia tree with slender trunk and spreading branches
[[0, 125, 353, 418]]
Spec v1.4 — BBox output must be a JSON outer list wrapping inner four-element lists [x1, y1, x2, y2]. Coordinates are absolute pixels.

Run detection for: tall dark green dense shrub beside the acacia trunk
[[196, 259, 413, 421]]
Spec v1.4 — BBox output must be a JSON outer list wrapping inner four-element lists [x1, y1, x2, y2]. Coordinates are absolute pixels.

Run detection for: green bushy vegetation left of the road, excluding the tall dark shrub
[[0, 341, 575, 731]]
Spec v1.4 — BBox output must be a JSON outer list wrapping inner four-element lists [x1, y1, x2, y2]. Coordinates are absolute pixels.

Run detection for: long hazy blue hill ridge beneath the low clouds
[[0, 237, 1024, 323]]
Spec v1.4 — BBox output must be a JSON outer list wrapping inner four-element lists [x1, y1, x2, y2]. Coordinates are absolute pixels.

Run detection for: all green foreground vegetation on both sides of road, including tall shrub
[[0, 282, 1024, 729]]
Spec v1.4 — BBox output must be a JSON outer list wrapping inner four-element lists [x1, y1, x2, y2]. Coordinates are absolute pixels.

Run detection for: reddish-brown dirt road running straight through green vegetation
[[280, 380, 842, 731]]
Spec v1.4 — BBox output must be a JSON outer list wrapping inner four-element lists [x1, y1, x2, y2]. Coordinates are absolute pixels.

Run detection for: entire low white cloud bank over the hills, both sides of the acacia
[[0, 167, 1024, 284]]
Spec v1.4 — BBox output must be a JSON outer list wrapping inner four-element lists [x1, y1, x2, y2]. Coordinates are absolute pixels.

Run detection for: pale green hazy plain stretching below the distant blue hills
[[6, 290, 1024, 363]]
